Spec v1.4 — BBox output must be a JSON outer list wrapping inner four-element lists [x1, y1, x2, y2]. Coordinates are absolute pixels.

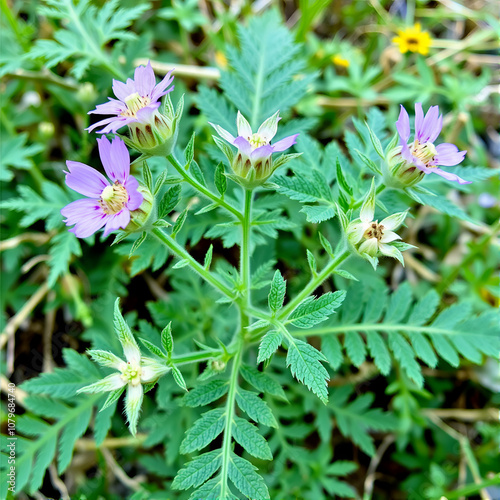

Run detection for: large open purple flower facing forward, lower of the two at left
[[61, 137, 143, 238]]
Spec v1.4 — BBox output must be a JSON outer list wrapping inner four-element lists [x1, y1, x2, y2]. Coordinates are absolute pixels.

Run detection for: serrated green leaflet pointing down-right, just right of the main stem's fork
[[286, 337, 330, 404]]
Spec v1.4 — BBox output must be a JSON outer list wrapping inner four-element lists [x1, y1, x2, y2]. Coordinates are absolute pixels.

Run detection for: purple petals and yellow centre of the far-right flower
[[396, 103, 470, 184]]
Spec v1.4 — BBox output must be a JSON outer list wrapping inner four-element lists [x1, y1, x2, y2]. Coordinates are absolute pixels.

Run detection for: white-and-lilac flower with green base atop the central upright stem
[[210, 111, 299, 184]]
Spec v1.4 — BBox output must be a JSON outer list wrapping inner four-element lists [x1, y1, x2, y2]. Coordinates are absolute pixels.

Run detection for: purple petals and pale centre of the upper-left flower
[[86, 62, 174, 134]]
